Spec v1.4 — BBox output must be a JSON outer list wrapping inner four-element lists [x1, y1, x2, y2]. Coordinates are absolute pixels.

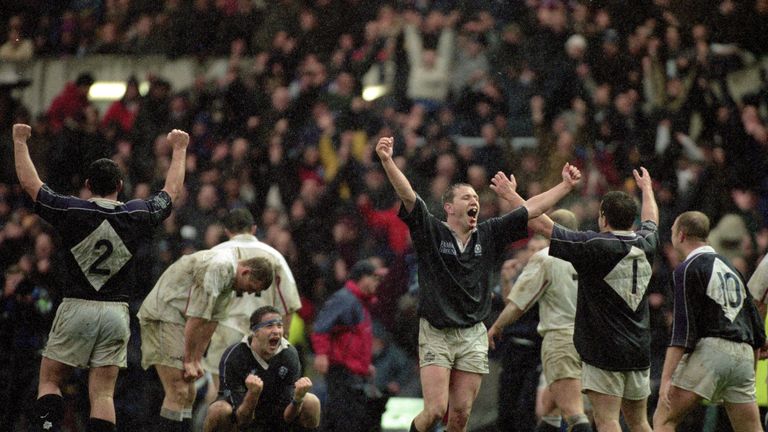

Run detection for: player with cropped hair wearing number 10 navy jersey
[[653, 211, 765, 432]]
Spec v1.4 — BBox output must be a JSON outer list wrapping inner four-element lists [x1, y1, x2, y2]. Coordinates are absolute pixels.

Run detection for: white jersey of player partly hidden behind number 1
[[507, 247, 578, 336]]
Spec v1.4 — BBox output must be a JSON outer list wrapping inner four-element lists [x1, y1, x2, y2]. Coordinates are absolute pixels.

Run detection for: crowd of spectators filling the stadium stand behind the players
[[0, 0, 768, 430]]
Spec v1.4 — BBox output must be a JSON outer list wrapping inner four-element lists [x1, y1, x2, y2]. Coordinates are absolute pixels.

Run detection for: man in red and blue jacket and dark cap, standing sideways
[[312, 260, 387, 432]]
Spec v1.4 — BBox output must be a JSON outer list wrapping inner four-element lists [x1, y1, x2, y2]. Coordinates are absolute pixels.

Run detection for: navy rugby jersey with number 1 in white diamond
[[549, 221, 659, 371]]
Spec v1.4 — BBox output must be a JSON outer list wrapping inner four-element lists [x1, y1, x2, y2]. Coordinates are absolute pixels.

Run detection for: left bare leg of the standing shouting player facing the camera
[[413, 365, 451, 432]]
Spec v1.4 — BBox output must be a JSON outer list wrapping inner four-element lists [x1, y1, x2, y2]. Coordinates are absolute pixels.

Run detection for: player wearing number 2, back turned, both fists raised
[[13, 124, 189, 432]]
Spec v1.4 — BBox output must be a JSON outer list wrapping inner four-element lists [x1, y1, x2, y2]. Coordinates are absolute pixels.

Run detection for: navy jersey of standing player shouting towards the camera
[[399, 196, 528, 329]]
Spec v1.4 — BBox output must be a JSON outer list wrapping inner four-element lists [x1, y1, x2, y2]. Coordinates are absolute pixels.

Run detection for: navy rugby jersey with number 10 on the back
[[670, 246, 765, 352]]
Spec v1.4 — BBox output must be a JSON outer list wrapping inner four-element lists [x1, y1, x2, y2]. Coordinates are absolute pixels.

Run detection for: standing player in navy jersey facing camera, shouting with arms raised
[[376, 137, 581, 432]]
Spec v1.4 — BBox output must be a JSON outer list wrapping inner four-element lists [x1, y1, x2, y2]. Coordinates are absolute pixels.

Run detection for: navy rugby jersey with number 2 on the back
[[35, 185, 172, 301]]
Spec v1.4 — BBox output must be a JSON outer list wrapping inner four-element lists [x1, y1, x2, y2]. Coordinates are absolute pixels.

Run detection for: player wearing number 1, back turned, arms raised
[[531, 168, 659, 432]]
